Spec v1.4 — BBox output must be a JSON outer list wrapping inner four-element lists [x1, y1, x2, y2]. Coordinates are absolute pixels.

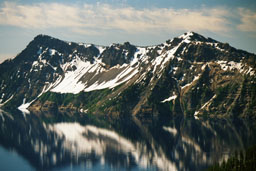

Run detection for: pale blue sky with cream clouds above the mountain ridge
[[0, 0, 256, 62]]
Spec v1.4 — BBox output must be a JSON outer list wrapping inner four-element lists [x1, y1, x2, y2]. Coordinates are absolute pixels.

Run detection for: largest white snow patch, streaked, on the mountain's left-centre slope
[[50, 57, 138, 94]]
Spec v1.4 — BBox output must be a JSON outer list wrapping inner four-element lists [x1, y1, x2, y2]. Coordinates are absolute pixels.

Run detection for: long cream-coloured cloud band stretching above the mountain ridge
[[0, 2, 230, 35]]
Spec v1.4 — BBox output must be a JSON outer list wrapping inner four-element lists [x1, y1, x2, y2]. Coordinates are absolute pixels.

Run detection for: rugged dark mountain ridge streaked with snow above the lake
[[0, 32, 256, 117]]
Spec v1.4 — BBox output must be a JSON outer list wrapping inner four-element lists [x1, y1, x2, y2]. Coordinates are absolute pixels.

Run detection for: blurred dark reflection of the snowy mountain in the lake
[[0, 111, 256, 170]]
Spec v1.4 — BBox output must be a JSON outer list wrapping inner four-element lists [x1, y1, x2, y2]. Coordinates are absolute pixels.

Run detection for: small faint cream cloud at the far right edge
[[237, 8, 256, 32]]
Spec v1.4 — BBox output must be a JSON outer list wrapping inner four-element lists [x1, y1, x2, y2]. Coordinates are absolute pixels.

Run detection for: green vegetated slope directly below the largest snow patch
[[39, 84, 142, 114]]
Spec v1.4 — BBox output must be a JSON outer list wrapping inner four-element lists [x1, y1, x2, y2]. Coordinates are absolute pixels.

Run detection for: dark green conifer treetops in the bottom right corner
[[208, 145, 256, 171]]
